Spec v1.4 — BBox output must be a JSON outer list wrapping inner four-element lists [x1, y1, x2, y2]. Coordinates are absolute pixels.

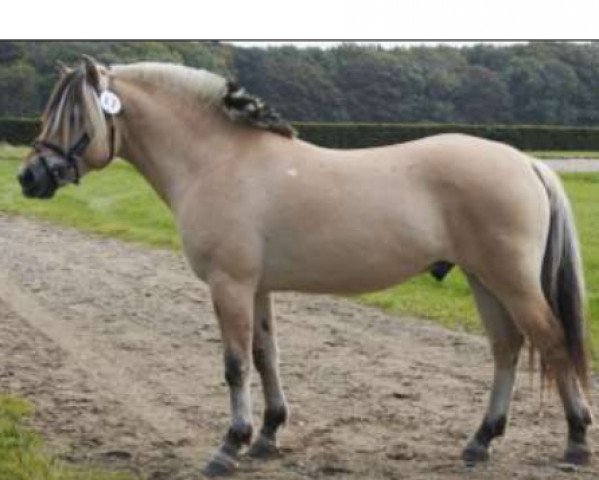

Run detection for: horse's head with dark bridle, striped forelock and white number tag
[[18, 56, 121, 198]]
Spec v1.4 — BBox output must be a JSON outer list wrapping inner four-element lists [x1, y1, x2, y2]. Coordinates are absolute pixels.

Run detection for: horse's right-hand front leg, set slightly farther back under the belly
[[248, 294, 288, 458]]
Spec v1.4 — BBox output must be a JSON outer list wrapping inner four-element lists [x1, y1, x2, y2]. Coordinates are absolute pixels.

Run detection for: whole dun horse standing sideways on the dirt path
[[18, 57, 592, 476]]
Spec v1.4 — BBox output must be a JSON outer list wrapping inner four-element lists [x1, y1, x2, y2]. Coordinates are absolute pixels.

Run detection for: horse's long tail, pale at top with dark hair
[[533, 160, 589, 390]]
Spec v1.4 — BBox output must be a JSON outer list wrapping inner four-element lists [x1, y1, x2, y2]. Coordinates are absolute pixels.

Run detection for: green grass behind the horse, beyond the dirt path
[[0, 147, 599, 367]]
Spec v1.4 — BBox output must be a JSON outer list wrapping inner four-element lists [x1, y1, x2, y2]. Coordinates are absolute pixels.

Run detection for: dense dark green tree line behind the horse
[[0, 41, 599, 126]]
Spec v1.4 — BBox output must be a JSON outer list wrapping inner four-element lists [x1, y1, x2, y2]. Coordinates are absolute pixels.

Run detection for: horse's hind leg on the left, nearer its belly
[[462, 275, 524, 463]]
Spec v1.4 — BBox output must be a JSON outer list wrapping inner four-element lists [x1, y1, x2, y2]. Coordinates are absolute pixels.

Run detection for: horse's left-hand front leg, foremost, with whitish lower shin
[[203, 274, 255, 477]]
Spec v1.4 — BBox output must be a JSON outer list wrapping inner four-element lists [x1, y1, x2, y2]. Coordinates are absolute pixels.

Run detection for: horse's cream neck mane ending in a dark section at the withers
[[112, 62, 296, 137]]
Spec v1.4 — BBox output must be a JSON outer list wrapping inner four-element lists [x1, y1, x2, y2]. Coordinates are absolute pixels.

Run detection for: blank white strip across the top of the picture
[[2, 0, 599, 42]]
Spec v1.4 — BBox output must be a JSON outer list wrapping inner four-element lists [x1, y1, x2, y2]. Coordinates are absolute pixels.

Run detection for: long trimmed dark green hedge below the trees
[[0, 118, 599, 150]]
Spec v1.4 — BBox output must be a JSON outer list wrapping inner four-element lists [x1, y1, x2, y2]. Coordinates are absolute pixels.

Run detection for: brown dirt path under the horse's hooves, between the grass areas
[[0, 216, 599, 480]]
